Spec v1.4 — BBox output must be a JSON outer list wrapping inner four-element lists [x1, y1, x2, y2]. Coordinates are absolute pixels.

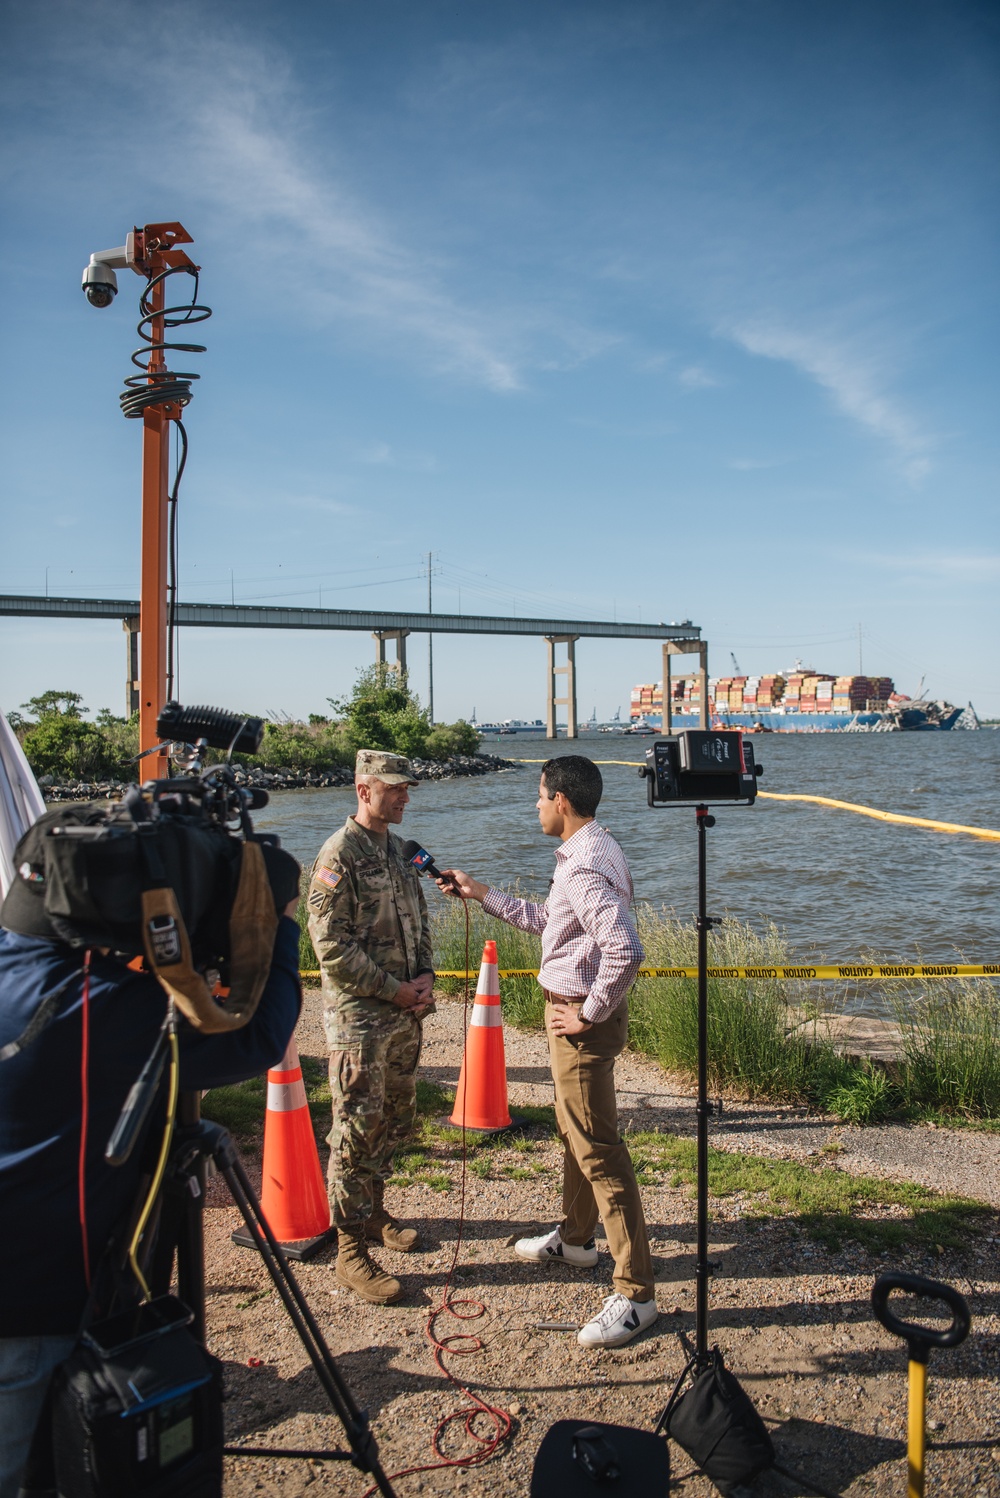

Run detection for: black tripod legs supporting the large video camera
[[148, 1092, 394, 1498]]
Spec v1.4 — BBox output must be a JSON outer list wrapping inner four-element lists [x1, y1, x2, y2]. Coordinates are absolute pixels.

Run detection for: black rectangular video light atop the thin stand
[[639, 728, 763, 806]]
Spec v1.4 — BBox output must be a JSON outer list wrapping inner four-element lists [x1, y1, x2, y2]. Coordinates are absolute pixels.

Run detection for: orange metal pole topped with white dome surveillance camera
[[84, 223, 208, 779]]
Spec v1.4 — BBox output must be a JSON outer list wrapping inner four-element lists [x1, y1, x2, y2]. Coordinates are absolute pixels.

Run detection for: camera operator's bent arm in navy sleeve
[[180, 914, 302, 1092]]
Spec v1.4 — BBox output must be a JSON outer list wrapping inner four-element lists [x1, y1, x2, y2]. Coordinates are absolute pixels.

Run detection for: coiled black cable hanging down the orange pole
[[118, 265, 211, 701]]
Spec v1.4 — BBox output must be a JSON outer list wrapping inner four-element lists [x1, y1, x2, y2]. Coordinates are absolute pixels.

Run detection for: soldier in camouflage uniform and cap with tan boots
[[308, 749, 434, 1305]]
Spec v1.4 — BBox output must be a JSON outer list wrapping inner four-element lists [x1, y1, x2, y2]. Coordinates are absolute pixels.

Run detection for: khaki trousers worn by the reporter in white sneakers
[[545, 993, 654, 1300]]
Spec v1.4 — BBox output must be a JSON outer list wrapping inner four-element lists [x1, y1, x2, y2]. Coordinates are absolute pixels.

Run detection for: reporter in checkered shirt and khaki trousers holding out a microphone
[[439, 755, 657, 1347]]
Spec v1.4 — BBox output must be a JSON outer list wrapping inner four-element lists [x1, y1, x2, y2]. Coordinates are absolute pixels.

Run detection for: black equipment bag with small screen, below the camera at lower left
[[52, 1296, 223, 1498]]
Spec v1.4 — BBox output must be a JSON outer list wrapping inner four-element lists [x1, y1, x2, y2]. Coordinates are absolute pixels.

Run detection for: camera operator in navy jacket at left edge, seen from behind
[[0, 828, 301, 1498]]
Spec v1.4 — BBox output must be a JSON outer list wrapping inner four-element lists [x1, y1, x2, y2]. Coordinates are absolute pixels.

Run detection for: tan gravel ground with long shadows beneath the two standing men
[[205, 990, 1000, 1498]]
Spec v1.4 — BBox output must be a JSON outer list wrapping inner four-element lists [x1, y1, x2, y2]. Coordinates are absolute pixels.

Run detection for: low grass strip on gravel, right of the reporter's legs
[[627, 1134, 991, 1252]]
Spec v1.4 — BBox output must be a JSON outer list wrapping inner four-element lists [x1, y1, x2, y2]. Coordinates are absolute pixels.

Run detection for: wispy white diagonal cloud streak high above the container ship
[[722, 322, 934, 482]]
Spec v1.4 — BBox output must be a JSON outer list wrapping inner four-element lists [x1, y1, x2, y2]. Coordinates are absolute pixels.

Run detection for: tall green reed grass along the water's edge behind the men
[[299, 888, 1000, 1124]]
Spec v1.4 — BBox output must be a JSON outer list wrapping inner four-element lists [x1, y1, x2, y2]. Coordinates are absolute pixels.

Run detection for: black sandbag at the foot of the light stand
[[659, 1347, 774, 1495]]
